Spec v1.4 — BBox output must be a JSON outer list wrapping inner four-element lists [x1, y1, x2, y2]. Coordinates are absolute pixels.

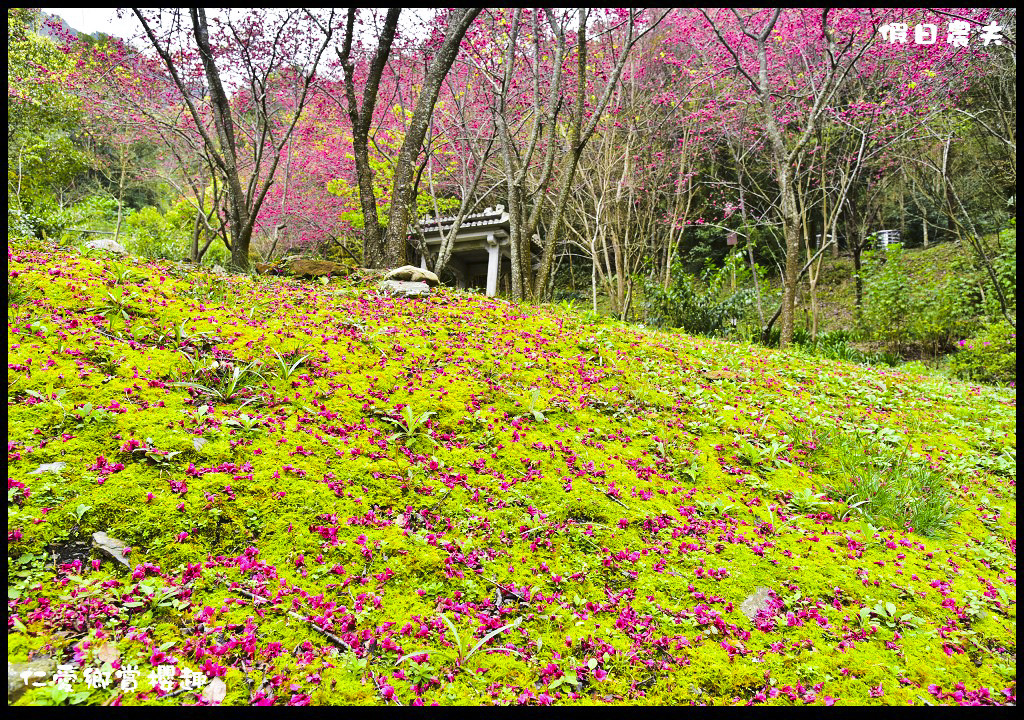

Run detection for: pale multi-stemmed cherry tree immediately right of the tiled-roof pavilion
[[469, 8, 664, 299]]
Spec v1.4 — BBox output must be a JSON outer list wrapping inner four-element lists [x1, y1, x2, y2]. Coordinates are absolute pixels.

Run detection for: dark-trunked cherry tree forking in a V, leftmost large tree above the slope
[[133, 8, 334, 269]]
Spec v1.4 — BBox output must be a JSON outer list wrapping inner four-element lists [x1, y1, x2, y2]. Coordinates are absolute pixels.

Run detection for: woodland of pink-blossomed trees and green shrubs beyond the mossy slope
[[7, 8, 1016, 382]]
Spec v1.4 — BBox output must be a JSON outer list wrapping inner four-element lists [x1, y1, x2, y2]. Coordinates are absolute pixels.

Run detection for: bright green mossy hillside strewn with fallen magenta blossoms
[[7, 249, 1016, 705]]
